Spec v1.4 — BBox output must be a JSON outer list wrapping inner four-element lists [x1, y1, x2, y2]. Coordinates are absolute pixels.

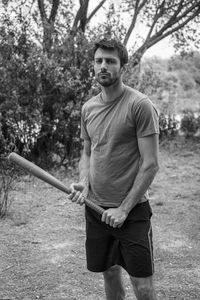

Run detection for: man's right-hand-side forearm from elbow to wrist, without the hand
[[120, 165, 158, 214]]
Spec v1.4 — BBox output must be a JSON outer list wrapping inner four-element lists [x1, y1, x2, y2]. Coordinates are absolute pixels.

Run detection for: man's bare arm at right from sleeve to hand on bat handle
[[102, 134, 159, 227]]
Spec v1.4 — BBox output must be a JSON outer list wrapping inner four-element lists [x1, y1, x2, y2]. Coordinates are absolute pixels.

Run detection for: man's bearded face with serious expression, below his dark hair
[[94, 48, 122, 87]]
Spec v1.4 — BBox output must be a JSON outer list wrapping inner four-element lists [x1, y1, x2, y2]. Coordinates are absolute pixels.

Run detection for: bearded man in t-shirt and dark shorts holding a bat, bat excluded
[[69, 39, 159, 300]]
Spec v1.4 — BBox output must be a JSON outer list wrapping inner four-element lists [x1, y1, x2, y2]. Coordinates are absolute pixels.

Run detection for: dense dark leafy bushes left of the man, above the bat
[[0, 16, 92, 166]]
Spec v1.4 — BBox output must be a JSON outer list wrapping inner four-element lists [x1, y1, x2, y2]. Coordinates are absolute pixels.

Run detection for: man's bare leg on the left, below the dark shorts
[[103, 266, 125, 300]]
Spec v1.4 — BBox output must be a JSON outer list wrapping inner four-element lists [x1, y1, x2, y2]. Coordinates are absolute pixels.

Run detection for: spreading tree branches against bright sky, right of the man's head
[[121, 0, 200, 64]]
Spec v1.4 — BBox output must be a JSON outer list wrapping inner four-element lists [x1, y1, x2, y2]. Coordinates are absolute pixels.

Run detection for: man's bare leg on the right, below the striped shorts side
[[130, 276, 157, 300]]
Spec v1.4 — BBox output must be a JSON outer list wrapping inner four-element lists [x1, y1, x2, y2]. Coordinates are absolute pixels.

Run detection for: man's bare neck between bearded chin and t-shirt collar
[[101, 81, 125, 103]]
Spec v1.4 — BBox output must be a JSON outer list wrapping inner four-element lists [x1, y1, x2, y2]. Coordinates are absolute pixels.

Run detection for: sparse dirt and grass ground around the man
[[0, 142, 200, 300]]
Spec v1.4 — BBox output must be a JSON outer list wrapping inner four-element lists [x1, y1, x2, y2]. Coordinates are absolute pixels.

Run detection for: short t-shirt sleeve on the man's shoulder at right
[[134, 98, 159, 138]]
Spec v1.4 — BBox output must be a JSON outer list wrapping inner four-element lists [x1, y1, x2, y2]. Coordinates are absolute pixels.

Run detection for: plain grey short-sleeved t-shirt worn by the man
[[81, 86, 159, 207]]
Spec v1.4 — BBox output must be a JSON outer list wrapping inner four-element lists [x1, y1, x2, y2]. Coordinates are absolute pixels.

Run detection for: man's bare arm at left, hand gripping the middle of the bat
[[68, 140, 91, 205]]
